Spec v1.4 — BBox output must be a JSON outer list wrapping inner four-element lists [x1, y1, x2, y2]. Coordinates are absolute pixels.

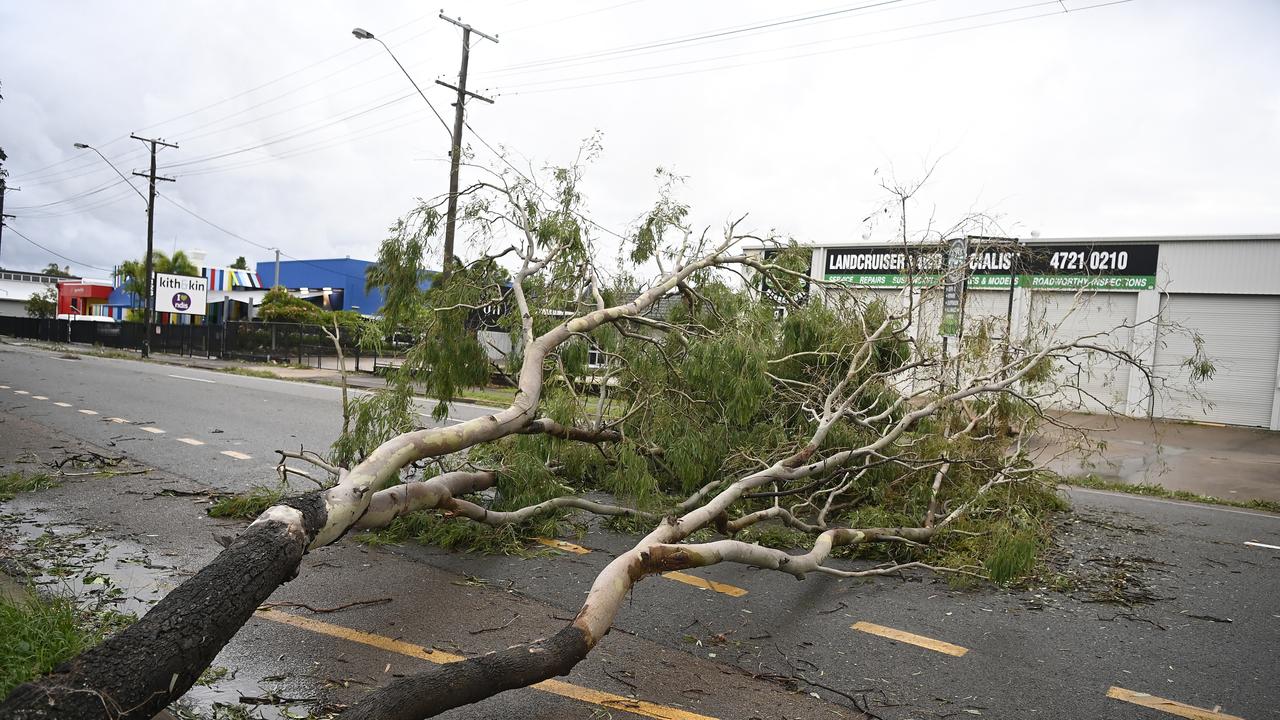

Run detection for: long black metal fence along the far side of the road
[[0, 316, 399, 372]]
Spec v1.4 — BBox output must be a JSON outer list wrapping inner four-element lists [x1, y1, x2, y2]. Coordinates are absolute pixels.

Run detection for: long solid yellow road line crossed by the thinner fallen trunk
[[256, 610, 716, 720]]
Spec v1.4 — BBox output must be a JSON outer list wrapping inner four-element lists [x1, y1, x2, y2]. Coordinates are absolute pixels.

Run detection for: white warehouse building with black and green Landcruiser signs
[[810, 234, 1280, 430]]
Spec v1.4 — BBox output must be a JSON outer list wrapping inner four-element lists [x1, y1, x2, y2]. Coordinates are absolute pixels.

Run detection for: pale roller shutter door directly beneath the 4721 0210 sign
[[1030, 292, 1138, 413]]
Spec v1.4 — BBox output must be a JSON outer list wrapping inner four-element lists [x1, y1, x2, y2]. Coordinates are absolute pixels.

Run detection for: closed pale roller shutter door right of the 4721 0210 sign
[[1155, 295, 1280, 427]]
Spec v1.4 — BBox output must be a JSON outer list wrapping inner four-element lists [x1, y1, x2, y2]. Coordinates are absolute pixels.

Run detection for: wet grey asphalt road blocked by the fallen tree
[[0, 346, 1280, 720]]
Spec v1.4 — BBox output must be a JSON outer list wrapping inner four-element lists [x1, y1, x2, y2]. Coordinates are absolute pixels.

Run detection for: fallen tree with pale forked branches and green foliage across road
[[0, 163, 1192, 719]]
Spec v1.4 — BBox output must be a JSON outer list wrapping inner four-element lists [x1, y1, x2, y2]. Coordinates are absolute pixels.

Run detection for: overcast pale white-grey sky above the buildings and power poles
[[0, 0, 1280, 277]]
